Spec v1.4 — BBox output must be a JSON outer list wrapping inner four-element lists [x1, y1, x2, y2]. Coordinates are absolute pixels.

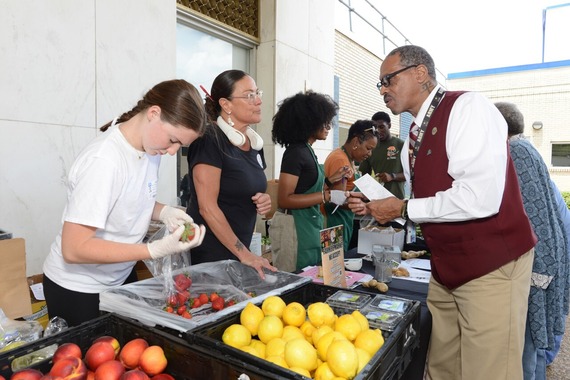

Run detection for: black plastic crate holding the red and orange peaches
[[0, 313, 284, 380]]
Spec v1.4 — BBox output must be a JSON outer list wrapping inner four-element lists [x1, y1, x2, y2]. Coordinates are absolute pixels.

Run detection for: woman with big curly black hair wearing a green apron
[[269, 91, 351, 272]]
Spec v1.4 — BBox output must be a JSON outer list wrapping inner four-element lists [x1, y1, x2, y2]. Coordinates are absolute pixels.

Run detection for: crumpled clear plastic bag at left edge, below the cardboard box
[[0, 309, 43, 352]]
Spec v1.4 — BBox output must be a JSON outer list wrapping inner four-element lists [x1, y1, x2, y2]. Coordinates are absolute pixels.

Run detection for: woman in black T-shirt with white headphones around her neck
[[186, 70, 276, 278]]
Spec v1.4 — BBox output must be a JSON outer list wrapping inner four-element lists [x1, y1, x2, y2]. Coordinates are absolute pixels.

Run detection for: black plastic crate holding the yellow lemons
[[185, 283, 420, 380]]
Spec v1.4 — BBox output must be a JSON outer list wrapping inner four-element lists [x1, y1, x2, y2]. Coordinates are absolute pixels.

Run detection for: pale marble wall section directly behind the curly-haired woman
[[257, 0, 335, 179]]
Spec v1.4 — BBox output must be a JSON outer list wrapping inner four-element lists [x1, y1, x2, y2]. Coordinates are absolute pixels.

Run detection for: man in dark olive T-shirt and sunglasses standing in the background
[[358, 111, 406, 199]]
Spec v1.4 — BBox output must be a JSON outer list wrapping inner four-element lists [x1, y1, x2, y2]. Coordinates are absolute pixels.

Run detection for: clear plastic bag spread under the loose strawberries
[[99, 260, 311, 331]]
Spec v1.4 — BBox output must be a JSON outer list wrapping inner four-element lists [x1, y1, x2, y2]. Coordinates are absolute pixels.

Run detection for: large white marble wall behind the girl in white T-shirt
[[0, 0, 176, 275]]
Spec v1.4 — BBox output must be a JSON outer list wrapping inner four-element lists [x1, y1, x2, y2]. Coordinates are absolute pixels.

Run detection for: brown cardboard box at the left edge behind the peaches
[[0, 238, 32, 319]]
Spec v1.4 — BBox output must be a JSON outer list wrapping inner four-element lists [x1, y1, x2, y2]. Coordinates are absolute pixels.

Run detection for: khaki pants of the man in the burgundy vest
[[427, 250, 534, 380]]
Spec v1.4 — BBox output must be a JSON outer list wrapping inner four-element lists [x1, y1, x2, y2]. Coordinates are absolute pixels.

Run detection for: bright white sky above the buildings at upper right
[[336, 0, 570, 75]]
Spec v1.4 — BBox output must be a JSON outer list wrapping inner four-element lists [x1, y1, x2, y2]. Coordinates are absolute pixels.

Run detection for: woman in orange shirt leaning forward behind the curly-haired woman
[[324, 120, 378, 252]]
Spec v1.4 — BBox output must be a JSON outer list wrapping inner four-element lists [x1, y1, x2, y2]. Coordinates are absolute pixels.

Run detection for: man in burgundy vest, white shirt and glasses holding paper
[[349, 45, 536, 380]]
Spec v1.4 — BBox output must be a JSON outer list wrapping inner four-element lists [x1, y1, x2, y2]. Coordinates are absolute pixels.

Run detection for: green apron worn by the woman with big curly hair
[[291, 144, 325, 270]]
